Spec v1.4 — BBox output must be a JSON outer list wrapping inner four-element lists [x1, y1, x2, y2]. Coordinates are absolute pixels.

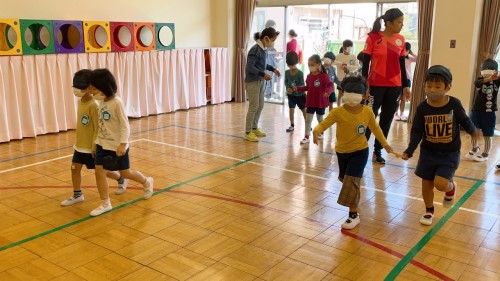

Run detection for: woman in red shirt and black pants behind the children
[[362, 8, 410, 164]]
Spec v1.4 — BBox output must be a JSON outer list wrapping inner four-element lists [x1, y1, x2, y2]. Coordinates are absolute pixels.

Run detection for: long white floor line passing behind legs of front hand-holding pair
[[141, 139, 499, 219]]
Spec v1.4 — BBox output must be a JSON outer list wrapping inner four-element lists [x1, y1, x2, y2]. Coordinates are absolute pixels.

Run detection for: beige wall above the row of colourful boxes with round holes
[[0, 0, 212, 48]]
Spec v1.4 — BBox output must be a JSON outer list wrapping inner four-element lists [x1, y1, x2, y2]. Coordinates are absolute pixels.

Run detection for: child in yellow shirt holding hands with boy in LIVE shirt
[[313, 76, 393, 229]]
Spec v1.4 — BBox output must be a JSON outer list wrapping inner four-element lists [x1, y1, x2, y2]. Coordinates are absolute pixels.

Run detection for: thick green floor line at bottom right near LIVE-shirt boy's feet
[[384, 180, 484, 281]]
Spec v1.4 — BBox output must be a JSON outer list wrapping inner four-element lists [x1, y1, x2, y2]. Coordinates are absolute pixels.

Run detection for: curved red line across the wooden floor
[[0, 186, 453, 281]]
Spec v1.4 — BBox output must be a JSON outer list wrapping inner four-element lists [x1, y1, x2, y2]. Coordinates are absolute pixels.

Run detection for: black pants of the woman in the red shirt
[[365, 86, 403, 151]]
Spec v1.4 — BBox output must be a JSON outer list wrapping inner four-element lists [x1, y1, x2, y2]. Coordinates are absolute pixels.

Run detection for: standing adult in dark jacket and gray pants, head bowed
[[244, 27, 280, 142]]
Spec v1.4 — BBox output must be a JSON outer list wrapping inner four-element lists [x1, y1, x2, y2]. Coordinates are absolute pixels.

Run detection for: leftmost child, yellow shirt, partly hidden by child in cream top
[[61, 69, 128, 206]]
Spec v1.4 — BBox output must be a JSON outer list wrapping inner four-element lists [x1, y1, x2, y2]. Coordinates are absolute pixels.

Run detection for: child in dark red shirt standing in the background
[[294, 55, 333, 144]]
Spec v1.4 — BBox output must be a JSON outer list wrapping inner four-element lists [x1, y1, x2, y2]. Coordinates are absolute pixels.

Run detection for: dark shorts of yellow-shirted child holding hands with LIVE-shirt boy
[[337, 148, 368, 179]]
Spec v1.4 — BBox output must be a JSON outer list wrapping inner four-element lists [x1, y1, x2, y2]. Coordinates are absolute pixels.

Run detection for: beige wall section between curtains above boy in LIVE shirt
[[430, 0, 483, 111]]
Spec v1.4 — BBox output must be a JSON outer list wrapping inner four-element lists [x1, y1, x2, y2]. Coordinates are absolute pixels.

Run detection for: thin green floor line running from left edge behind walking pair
[[0, 151, 273, 252]]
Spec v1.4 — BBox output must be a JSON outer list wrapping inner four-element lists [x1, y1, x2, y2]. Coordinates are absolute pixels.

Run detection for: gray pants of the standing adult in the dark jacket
[[245, 80, 264, 133]]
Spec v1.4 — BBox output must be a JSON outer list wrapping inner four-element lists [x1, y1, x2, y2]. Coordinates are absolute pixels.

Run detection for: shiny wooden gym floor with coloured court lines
[[0, 103, 500, 280]]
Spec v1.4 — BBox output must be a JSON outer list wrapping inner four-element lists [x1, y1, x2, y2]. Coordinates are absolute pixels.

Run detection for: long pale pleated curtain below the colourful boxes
[[0, 48, 231, 142]]
